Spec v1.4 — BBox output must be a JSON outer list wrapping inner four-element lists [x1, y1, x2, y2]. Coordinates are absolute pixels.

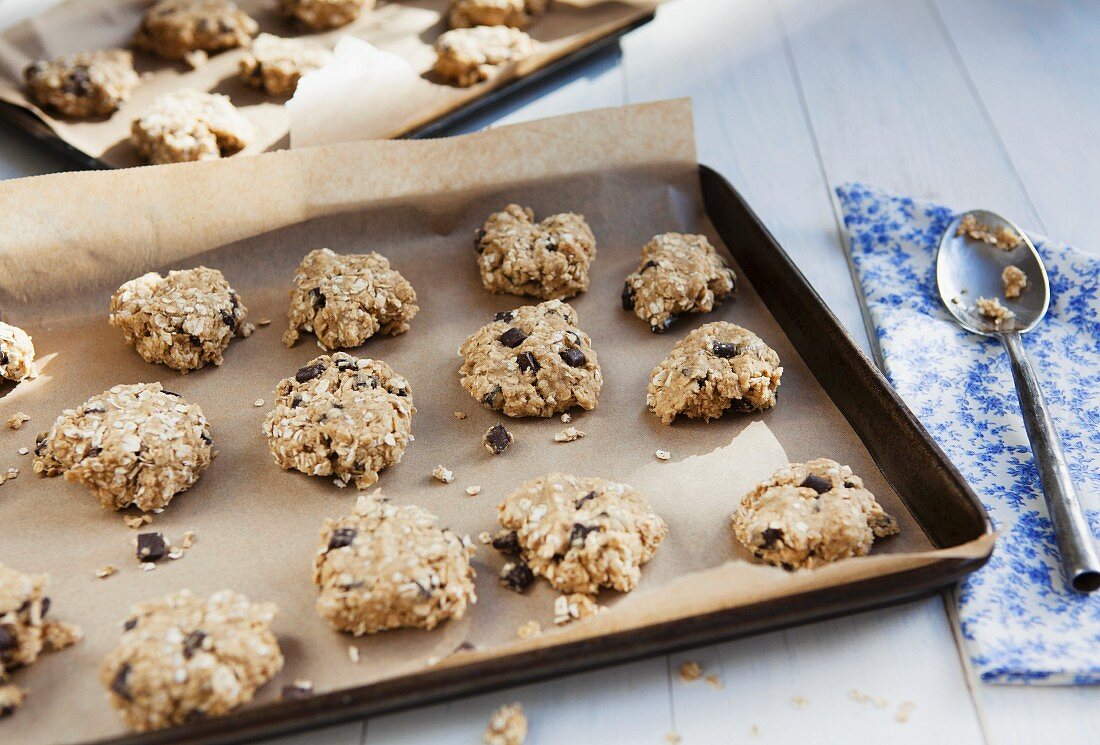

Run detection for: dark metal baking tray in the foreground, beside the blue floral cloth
[[85, 166, 992, 745]]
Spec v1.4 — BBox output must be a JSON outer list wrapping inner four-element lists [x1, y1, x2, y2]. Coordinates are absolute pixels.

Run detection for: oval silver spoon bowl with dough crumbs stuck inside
[[936, 209, 1051, 337]]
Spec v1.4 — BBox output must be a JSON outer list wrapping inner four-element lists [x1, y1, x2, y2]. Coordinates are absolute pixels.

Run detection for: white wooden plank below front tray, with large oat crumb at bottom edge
[[363, 657, 672, 745]]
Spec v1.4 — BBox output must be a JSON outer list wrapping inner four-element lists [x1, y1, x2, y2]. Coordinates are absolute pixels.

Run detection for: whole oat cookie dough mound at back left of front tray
[[110, 266, 252, 373]]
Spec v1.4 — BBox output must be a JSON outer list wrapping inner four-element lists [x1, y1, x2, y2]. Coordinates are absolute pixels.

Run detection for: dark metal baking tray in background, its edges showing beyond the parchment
[[0, 12, 655, 169]]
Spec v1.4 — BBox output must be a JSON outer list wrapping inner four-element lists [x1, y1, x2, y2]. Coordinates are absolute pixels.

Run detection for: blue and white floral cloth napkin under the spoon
[[836, 184, 1100, 684]]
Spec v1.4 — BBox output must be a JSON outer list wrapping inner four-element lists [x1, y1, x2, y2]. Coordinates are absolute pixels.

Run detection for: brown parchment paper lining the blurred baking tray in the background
[[0, 0, 659, 167]]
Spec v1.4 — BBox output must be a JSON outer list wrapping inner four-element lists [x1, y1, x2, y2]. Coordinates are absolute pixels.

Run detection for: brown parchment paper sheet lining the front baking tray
[[0, 101, 988, 745]]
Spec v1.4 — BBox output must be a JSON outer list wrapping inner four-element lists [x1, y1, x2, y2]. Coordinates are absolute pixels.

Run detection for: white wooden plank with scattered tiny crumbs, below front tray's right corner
[[672, 599, 982, 745]]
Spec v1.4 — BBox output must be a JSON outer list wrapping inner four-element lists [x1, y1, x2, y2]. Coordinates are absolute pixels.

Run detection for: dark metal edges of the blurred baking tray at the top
[[0, 0, 656, 168]]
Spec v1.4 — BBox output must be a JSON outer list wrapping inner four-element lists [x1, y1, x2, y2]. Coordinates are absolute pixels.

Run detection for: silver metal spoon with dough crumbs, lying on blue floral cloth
[[936, 209, 1100, 592]]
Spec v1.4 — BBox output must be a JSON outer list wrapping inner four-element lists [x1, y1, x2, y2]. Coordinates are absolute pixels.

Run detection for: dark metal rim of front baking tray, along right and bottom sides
[[55, 165, 992, 745]]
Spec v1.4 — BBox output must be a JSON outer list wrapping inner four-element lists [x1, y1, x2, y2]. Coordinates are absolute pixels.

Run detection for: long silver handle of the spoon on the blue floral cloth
[[1001, 332, 1100, 592]]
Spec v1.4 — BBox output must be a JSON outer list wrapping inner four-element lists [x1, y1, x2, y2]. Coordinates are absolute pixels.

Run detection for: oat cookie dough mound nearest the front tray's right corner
[[732, 458, 899, 569]]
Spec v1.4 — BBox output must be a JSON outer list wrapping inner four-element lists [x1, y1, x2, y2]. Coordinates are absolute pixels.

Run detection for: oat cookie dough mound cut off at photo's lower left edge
[[0, 563, 83, 719]]
